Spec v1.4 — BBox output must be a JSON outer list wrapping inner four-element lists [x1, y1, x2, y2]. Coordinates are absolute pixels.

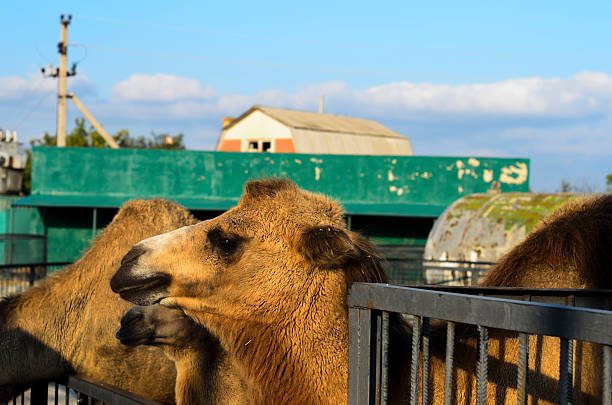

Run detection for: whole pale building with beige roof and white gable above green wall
[[216, 106, 412, 155]]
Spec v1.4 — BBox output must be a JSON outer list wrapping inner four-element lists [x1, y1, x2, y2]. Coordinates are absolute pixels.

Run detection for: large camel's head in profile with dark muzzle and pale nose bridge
[[111, 179, 385, 323]]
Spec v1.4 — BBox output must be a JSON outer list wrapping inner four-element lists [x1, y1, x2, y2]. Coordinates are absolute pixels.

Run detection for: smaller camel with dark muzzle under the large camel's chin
[[116, 304, 248, 405]]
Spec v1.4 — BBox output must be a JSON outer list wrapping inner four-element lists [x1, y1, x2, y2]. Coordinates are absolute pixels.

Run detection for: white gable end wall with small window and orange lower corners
[[218, 111, 295, 153]]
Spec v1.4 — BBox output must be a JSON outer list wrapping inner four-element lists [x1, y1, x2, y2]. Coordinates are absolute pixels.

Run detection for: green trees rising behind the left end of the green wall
[[21, 118, 185, 195]]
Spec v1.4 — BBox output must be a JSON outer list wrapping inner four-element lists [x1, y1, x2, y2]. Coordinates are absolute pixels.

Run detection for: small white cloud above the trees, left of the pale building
[[112, 73, 215, 102]]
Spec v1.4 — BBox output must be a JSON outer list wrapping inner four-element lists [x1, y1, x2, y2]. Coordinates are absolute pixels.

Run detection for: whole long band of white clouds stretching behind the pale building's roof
[[104, 72, 612, 120]]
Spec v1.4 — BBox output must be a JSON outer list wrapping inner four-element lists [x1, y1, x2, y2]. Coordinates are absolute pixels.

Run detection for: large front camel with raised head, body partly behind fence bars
[[111, 179, 612, 404]]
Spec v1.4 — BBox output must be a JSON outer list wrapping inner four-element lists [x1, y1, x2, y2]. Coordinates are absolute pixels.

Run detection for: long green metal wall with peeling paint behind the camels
[[16, 147, 529, 261]]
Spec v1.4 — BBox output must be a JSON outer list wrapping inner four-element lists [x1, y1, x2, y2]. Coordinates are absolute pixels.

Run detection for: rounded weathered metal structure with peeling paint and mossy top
[[424, 193, 577, 281]]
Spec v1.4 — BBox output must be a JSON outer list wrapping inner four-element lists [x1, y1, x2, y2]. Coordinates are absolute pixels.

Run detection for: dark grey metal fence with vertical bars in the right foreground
[[348, 283, 612, 405]]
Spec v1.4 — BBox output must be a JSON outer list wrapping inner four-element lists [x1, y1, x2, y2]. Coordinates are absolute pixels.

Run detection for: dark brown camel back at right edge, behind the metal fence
[[482, 194, 612, 403]]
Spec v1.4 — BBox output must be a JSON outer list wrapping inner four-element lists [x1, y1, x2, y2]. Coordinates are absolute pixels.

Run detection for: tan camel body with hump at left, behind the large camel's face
[[0, 200, 196, 403]]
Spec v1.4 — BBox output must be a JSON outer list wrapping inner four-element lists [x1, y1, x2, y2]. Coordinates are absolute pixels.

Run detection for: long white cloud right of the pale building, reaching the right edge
[[354, 72, 612, 118]]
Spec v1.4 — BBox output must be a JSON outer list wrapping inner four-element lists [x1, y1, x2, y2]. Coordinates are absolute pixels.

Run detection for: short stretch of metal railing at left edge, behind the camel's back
[[0, 262, 70, 297]]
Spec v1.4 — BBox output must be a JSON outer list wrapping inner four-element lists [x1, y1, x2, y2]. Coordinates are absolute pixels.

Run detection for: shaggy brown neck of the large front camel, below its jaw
[[194, 304, 348, 404]]
